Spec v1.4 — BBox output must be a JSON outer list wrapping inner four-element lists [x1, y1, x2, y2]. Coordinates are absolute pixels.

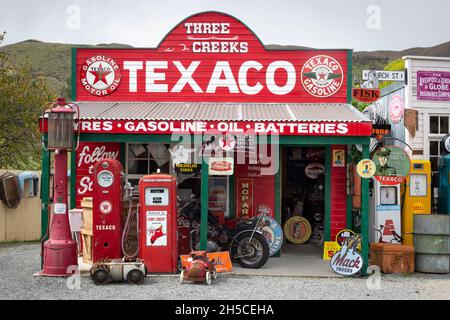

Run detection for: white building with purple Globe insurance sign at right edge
[[403, 56, 450, 210]]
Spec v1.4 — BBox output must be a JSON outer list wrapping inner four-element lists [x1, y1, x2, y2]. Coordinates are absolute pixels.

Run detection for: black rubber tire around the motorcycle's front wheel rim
[[233, 230, 270, 269]]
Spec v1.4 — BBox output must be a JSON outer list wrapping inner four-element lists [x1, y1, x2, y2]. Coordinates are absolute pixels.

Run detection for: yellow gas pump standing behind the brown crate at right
[[402, 160, 431, 245]]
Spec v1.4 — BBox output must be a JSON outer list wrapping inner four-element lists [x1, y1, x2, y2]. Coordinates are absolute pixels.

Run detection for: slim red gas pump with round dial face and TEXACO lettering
[[92, 159, 124, 262]]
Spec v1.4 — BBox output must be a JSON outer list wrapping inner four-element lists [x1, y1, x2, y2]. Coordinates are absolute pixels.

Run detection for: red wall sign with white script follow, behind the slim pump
[[75, 142, 120, 207]]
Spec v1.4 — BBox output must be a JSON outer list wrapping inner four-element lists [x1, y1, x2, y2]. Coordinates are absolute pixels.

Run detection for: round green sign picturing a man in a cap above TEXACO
[[372, 146, 411, 185]]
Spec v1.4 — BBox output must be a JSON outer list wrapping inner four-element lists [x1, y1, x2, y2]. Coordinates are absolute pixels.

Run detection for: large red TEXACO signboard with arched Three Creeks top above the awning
[[74, 12, 351, 103]]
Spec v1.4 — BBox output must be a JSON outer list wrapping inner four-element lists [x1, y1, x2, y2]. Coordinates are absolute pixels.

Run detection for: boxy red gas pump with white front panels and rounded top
[[139, 173, 178, 273]]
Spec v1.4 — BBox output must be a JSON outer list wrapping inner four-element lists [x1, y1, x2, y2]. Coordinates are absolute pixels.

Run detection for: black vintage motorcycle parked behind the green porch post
[[179, 198, 270, 269]]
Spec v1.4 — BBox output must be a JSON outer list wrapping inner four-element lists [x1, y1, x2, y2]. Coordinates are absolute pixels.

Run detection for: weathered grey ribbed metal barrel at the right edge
[[413, 214, 450, 273]]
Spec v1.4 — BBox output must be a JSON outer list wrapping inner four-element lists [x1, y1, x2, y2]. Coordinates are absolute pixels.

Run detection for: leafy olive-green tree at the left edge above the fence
[[0, 32, 51, 169]]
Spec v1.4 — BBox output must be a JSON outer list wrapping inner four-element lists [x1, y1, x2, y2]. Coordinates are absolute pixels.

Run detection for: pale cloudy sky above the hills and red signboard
[[0, 0, 450, 51]]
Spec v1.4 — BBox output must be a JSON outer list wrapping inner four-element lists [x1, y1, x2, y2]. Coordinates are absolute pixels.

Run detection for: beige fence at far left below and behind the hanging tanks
[[0, 170, 41, 242]]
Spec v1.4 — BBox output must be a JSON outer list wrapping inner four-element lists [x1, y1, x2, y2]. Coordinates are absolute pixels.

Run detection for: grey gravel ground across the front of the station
[[0, 244, 450, 300]]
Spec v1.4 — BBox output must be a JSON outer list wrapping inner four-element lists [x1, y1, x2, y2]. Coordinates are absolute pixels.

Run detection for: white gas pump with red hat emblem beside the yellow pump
[[369, 179, 401, 243]]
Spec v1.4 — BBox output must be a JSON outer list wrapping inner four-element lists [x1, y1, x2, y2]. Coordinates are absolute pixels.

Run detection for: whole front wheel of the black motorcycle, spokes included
[[231, 231, 270, 269]]
